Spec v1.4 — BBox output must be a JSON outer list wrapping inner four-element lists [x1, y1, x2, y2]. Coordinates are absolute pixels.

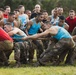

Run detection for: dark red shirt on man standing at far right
[[66, 16, 76, 32]]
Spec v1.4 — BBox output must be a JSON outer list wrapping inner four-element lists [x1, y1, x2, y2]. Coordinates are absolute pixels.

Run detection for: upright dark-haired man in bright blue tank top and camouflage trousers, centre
[[25, 13, 43, 61]]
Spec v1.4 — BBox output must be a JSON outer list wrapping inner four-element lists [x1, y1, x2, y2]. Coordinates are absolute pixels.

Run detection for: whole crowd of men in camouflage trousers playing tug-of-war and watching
[[0, 4, 76, 67]]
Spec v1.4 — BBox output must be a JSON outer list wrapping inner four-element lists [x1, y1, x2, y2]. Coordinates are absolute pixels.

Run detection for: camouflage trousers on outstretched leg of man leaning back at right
[[39, 38, 74, 65]]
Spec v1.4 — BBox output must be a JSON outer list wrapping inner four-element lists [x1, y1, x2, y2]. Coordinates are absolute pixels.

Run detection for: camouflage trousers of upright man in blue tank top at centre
[[29, 40, 44, 61]]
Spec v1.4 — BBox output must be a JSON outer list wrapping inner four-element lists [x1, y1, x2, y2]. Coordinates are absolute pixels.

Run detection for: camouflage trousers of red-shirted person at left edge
[[0, 40, 13, 65]]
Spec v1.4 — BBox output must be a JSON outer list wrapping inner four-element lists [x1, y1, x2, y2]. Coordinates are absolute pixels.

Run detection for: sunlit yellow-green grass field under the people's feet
[[0, 51, 76, 75]]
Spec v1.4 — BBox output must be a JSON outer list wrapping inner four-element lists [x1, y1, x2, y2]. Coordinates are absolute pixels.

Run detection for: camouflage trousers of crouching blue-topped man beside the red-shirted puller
[[14, 41, 29, 64]]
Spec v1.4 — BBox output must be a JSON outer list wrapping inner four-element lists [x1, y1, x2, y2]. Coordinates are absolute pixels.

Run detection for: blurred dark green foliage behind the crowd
[[0, 0, 76, 14]]
